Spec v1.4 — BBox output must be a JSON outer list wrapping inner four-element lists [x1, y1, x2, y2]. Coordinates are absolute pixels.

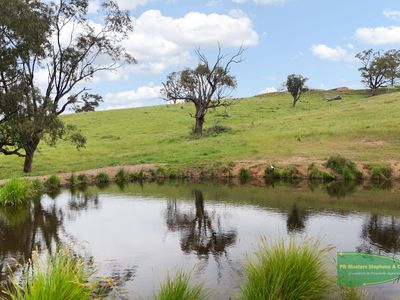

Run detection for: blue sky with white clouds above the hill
[[75, 0, 400, 109]]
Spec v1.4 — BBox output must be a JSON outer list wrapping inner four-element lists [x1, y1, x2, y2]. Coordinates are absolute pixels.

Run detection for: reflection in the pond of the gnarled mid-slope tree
[[166, 190, 237, 260]]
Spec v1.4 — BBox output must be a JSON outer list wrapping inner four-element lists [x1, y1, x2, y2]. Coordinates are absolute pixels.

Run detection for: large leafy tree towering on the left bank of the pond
[[0, 0, 135, 172]]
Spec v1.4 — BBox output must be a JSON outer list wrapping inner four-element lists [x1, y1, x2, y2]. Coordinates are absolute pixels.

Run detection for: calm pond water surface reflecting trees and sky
[[0, 182, 400, 299]]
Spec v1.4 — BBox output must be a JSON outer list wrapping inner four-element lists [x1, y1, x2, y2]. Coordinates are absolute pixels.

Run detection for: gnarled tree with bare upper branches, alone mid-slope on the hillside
[[161, 47, 244, 135]]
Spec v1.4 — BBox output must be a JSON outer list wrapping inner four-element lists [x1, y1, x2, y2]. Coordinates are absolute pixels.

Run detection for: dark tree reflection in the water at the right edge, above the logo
[[357, 214, 400, 254]]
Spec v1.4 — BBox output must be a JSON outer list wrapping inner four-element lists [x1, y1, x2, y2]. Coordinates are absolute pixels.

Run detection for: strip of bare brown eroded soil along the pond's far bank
[[0, 157, 400, 186]]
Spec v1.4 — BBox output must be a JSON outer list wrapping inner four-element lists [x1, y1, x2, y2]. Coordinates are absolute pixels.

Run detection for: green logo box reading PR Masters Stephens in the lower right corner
[[337, 252, 400, 288]]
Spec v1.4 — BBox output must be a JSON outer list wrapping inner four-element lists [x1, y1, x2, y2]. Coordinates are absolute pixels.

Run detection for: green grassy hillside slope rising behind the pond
[[0, 91, 400, 178]]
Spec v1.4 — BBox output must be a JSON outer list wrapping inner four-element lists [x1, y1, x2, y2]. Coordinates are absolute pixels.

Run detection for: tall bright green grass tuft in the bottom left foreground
[[6, 248, 97, 300]]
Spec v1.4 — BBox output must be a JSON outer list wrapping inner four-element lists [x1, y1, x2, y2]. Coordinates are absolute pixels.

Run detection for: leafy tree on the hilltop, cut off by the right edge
[[356, 49, 400, 95]]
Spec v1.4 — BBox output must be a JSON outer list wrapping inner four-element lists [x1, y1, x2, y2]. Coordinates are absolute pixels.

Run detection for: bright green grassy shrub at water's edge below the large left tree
[[0, 178, 30, 206]]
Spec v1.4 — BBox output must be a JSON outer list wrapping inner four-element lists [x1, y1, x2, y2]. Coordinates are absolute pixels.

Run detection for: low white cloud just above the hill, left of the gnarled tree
[[102, 83, 162, 109]]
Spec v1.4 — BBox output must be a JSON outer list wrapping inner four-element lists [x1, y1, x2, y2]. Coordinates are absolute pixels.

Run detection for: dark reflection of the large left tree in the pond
[[0, 192, 98, 285]]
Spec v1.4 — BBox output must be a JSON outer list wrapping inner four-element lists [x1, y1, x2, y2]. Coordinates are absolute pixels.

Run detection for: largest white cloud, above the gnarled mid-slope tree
[[124, 10, 258, 73]]
